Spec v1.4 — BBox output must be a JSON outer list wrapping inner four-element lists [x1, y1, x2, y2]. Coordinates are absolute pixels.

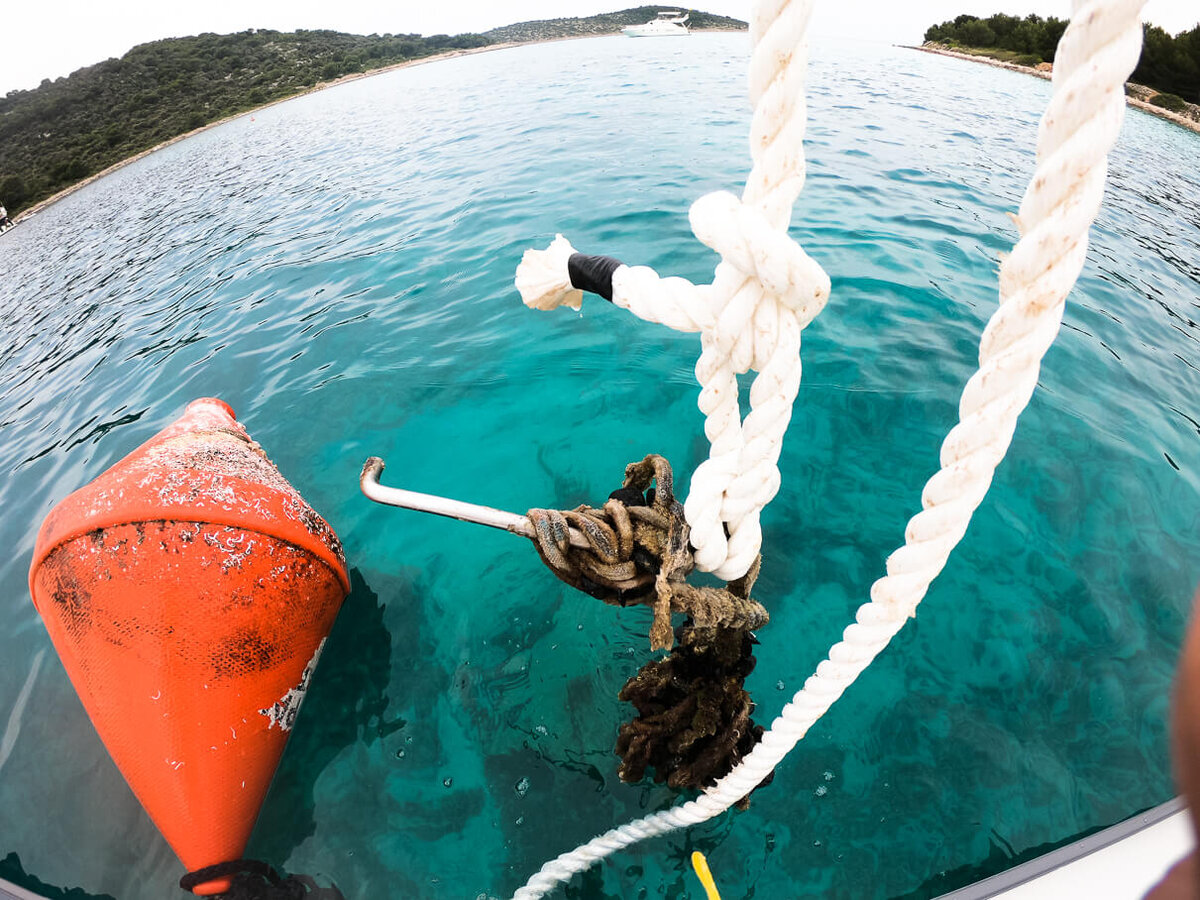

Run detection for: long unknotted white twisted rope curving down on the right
[[514, 0, 1144, 900]]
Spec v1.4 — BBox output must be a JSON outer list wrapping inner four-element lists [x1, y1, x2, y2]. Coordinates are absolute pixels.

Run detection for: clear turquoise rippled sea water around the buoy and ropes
[[0, 35, 1200, 900]]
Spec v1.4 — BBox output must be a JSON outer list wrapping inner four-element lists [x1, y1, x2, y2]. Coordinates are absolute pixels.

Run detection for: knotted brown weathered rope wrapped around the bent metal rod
[[527, 454, 768, 650]]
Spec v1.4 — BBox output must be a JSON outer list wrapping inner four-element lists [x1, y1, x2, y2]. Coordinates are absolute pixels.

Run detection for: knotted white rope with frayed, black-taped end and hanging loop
[[516, 0, 829, 581]]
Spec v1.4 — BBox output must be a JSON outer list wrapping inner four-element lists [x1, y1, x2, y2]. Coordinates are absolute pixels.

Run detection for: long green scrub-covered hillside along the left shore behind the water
[[0, 6, 745, 215]]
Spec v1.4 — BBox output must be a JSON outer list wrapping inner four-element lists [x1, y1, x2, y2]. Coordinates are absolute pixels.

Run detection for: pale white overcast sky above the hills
[[0, 0, 1200, 95]]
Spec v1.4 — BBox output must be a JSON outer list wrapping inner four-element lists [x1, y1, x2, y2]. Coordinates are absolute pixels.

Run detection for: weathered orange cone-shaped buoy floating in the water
[[29, 398, 349, 894]]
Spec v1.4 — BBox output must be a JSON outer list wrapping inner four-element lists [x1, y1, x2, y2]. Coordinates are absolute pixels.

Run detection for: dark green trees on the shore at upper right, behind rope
[[925, 13, 1200, 103]]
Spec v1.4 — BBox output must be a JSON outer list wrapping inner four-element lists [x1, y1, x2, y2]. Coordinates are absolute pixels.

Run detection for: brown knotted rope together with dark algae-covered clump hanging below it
[[528, 454, 770, 806]]
